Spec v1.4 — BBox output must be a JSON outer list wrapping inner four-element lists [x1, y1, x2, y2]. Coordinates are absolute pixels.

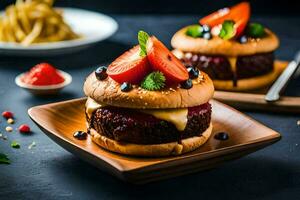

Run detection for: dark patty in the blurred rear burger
[[182, 52, 274, 80]]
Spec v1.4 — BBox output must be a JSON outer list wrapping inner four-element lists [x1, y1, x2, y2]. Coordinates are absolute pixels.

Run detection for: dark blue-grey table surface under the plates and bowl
[[0, 15, 300, 199]]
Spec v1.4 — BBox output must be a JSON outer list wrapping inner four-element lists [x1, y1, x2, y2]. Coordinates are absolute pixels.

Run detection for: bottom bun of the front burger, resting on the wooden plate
[[90, 123, 212, 157]]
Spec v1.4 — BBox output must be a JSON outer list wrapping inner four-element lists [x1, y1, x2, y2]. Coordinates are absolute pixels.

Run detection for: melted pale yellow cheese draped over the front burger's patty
[[85, 98, 188, 131]]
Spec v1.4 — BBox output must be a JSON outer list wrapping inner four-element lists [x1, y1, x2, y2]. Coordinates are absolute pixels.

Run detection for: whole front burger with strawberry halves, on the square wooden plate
[[83, 31, 214, 157]]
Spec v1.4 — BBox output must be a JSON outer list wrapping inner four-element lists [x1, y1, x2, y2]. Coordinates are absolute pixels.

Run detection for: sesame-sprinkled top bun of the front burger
[[83, 72, 214, 109]]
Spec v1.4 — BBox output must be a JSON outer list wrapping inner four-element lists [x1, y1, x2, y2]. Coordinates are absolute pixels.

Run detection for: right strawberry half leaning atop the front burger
[[147, 36, 189, 84]]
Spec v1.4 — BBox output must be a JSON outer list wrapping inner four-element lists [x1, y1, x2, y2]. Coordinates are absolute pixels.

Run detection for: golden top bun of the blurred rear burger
[[171, 26, 279, 56]]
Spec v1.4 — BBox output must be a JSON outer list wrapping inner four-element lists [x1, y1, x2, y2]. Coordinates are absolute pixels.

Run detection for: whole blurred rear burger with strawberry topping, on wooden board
[[171, 2, 280, 91]]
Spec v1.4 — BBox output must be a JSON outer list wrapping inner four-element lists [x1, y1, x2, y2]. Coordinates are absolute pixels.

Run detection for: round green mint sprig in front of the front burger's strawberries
[[141, 71, 166, 90]]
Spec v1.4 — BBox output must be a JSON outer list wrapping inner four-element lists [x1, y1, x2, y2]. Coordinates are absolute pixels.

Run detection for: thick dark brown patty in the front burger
[[88, 103, 211, 144]]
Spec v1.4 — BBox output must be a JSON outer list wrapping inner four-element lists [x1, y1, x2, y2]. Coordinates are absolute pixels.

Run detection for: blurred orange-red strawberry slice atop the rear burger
[[199, 2, 250, 37]]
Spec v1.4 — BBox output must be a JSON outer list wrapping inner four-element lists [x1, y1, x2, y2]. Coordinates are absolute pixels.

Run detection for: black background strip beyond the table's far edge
[[0, 0, 300, 15]]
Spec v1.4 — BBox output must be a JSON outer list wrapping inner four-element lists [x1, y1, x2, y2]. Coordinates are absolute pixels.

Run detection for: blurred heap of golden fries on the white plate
[[0, 0, 79, 46]]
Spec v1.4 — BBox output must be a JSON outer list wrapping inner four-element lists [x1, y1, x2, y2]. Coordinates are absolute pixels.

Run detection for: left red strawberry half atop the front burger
[[106, 46, 150, 84]]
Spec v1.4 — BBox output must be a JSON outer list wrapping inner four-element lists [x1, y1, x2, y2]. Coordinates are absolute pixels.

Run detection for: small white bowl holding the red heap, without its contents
[[15, 70, 72, 95]]
